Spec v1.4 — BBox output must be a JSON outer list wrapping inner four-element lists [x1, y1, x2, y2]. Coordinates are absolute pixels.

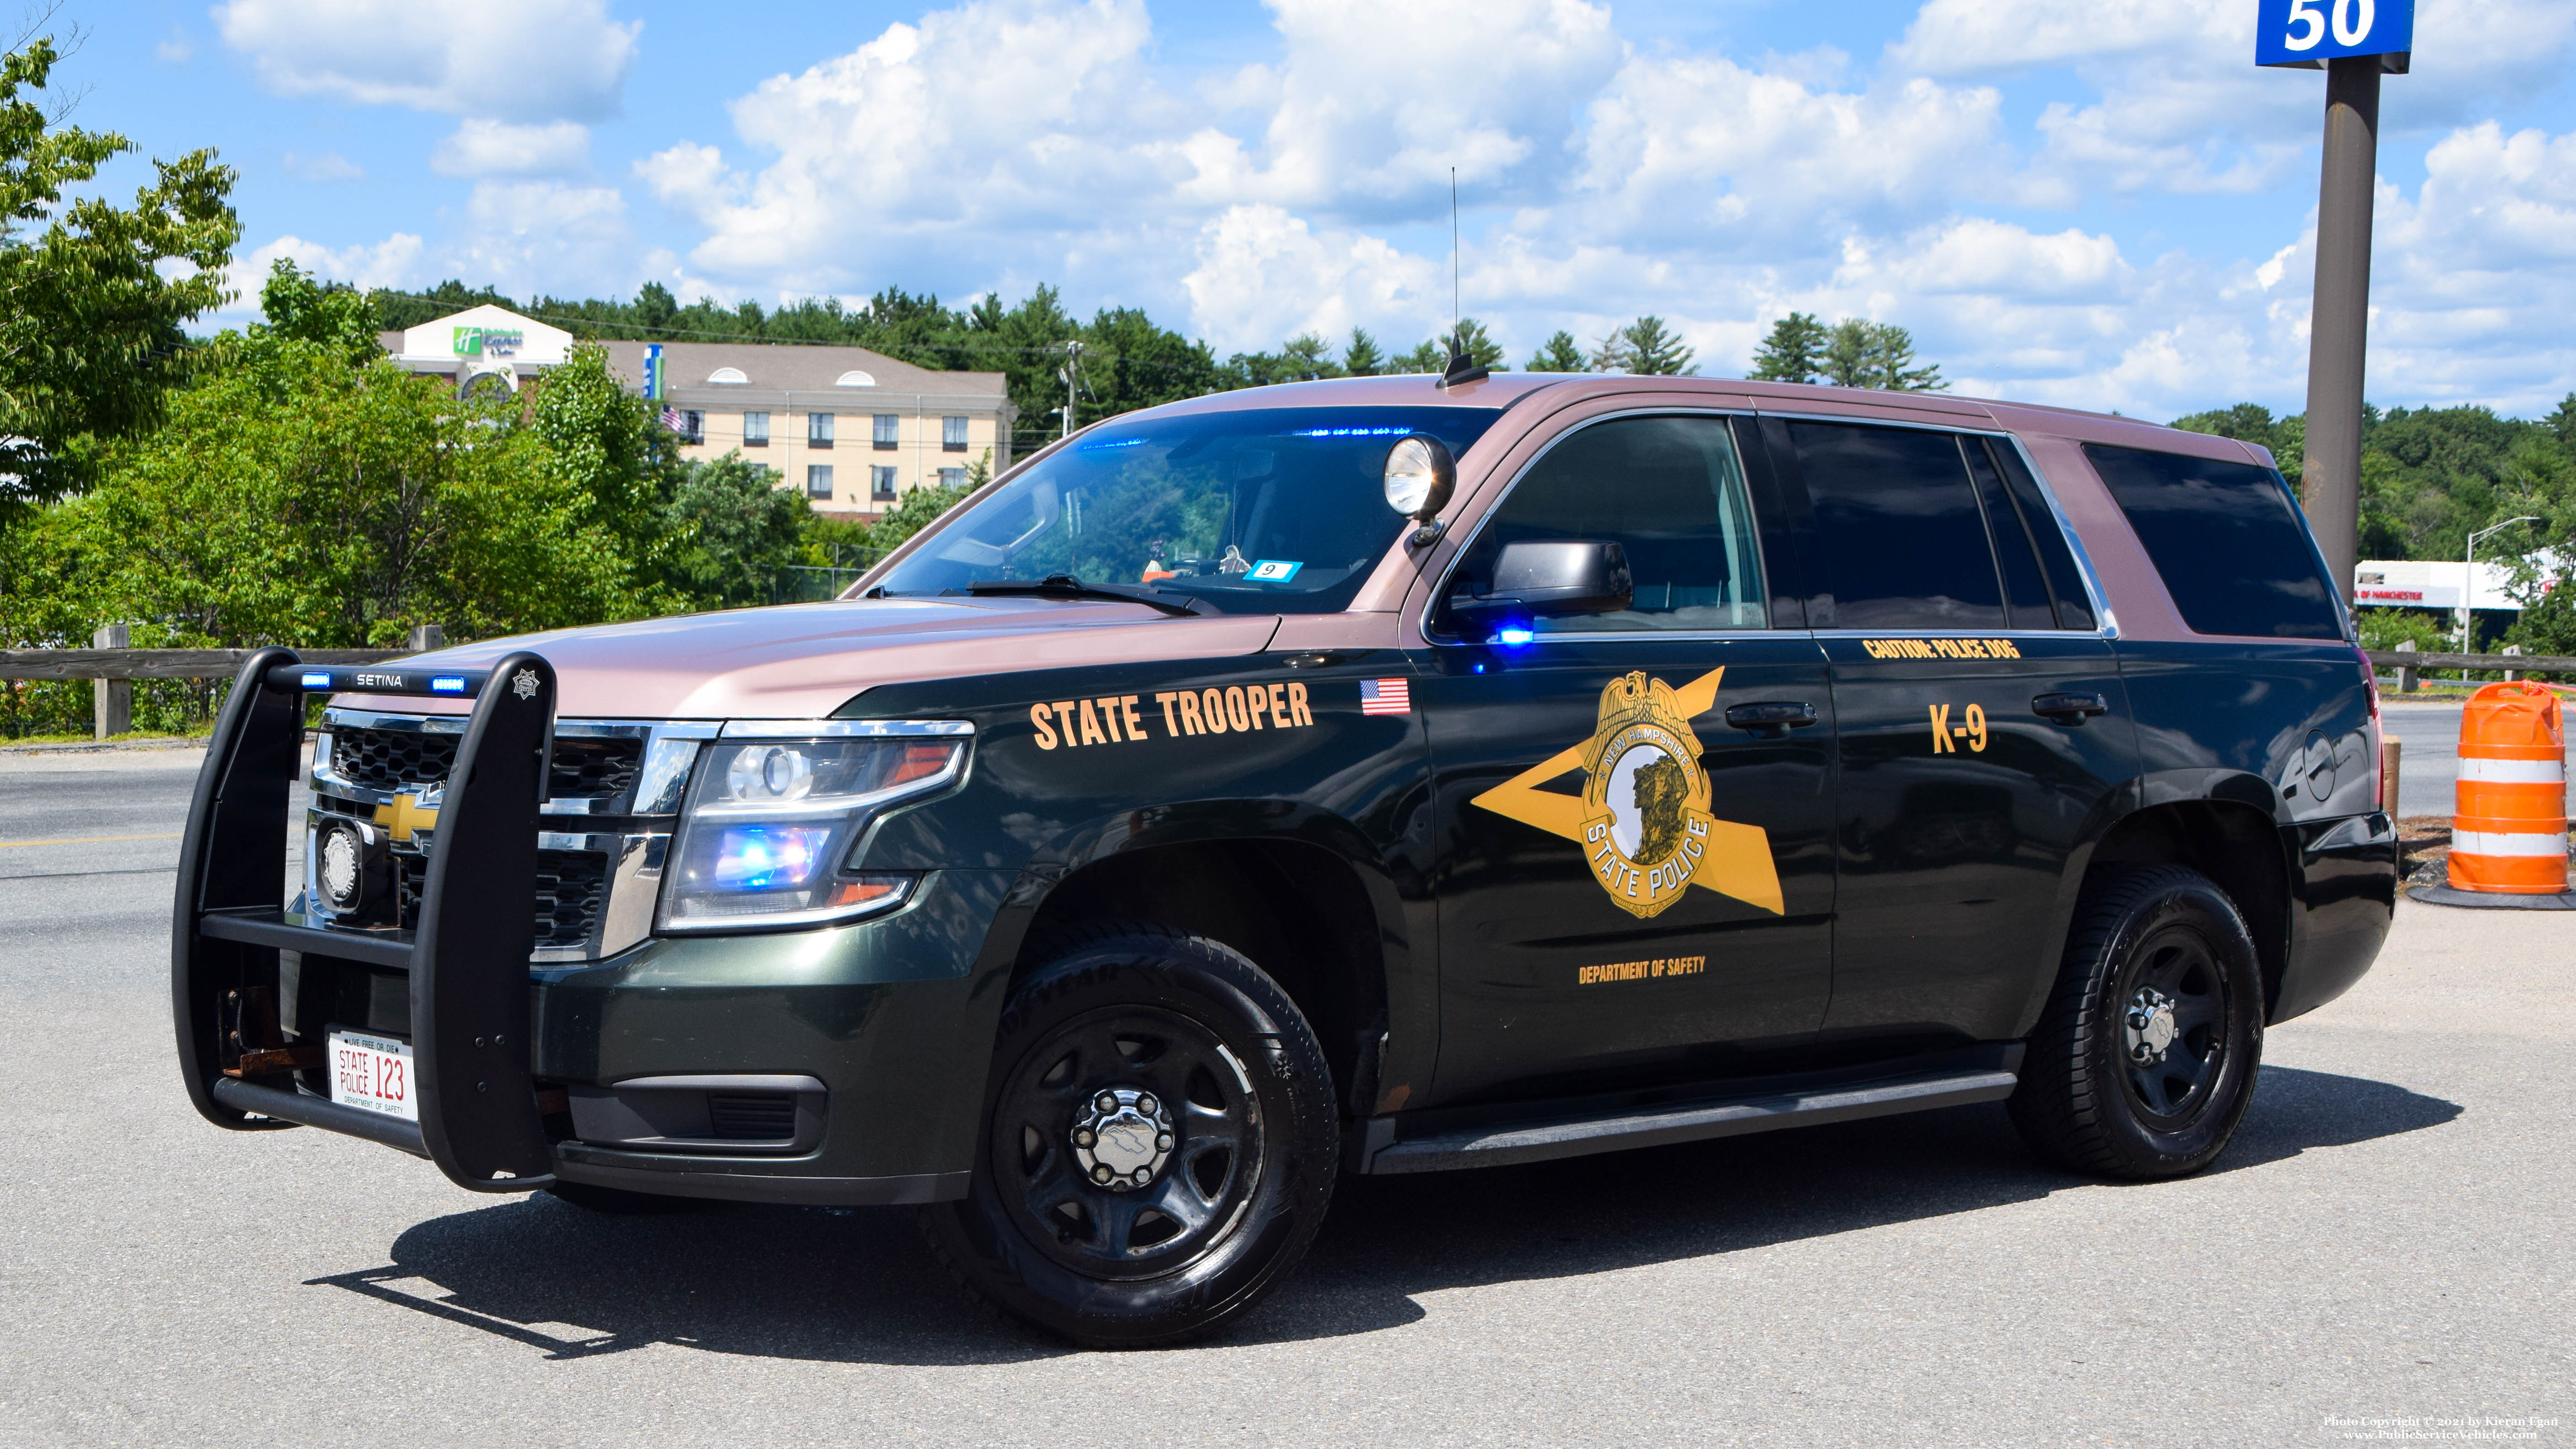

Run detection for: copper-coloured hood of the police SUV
[[358, 597, 1278, 721]]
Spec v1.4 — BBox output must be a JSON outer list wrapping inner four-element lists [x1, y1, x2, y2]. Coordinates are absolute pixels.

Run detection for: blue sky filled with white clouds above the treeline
[[70, 0, 2576, 420]]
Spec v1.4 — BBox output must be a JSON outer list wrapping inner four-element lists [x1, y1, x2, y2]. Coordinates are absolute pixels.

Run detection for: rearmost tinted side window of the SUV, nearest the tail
[[2084, 443, 2344, 638]]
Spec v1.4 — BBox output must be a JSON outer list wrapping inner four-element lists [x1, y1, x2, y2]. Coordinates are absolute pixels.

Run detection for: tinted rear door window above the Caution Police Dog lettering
[[1788, 422, 2004, 630]]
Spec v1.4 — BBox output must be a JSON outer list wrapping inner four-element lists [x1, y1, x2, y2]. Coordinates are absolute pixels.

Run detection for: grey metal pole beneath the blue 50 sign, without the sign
[[2298, 57, 2380, 587]]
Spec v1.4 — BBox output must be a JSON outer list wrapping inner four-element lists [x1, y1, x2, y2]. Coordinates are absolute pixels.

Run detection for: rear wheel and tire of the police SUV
[[2009, 865, 2262, 1181]]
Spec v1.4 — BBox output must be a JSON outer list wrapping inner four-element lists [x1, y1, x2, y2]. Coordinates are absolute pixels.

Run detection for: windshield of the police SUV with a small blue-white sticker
[[878, 407, 1502, 613]]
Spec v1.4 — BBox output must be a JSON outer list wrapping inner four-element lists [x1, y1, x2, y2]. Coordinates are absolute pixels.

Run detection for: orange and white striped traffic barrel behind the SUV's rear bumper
[[2450, 682, 2568, 896]]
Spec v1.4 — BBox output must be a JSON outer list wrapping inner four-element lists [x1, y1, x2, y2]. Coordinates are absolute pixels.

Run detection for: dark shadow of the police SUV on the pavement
[[312, 1066, 2460, 1364]]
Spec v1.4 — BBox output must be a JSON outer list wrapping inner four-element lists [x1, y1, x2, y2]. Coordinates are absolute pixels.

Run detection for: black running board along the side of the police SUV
[[1360, 1053, 2020, 1174]]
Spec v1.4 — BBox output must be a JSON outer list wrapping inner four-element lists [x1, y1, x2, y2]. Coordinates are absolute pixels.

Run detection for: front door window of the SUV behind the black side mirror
[[1450, 417, 1770, 633]]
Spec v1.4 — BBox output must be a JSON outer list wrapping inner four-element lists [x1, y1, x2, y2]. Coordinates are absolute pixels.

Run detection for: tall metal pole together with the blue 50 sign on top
[[2254, 0, 2414, 597]]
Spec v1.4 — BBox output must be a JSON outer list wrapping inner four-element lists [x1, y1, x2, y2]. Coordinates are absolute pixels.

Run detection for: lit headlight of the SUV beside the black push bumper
[[659, 726, 966, 932]]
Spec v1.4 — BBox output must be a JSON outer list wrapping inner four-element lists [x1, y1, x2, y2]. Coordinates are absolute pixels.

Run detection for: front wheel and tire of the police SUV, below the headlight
[[922, 924, 1339, 1349]]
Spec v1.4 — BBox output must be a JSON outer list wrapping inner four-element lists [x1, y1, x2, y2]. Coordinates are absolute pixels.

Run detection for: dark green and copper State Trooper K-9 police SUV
[[173, 368, 2398, 1346]]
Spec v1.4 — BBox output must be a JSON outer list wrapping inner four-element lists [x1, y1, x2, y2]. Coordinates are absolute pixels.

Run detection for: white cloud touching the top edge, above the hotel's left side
[[214, 0, 644, 121]]
